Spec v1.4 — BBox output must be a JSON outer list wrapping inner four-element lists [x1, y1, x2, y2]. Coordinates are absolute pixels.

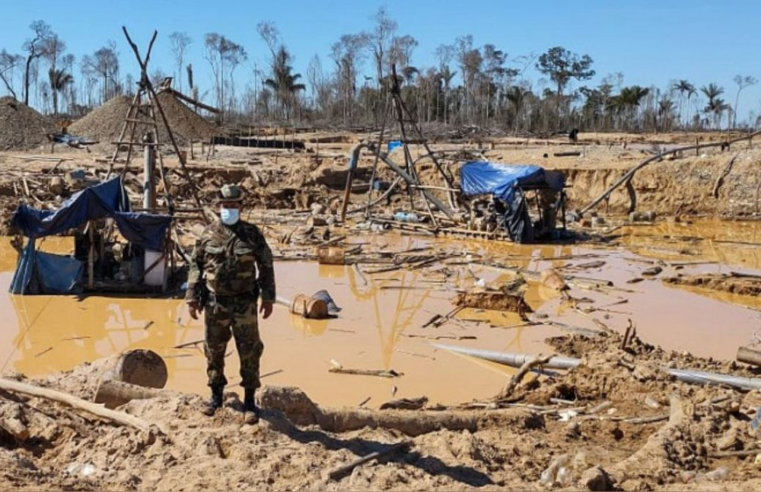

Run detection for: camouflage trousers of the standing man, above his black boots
[[204, 296, 264, 389]]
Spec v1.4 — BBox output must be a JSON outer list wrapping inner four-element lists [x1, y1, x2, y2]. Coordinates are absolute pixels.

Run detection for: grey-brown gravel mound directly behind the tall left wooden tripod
[[69, 93, 224, 145]]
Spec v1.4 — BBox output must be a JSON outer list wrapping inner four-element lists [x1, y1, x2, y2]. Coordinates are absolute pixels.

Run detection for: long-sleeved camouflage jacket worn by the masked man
[[185, 221, 275, 302]]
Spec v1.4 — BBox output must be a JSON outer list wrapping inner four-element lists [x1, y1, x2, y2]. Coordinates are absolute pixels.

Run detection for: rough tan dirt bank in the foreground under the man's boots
[[0, 328, 761, 490]]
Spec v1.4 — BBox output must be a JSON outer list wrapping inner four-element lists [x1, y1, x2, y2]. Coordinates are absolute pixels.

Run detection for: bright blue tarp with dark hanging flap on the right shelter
[[460, 161, 565, 243]]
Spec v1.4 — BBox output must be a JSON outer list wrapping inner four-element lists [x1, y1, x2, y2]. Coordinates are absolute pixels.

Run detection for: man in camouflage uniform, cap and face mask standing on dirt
[[185, 185, 275, 424]]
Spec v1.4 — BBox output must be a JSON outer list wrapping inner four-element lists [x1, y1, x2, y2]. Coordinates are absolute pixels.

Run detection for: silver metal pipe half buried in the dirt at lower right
[[431, 343, 761, 390]]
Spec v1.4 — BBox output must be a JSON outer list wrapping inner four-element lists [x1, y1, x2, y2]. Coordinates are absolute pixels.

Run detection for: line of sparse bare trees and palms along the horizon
[[0, 8, 761, 133]]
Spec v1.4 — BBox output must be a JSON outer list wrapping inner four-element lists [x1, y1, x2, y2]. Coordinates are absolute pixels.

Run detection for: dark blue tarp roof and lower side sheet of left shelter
[[10, 177, 172, 294]]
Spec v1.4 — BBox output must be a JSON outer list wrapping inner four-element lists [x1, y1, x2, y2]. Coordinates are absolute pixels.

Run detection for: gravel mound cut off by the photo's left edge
[[0, 96, 56, 150]]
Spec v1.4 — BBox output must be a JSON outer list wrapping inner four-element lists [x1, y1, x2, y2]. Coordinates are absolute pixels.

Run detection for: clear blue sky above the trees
[[0, 0, 761, 121]]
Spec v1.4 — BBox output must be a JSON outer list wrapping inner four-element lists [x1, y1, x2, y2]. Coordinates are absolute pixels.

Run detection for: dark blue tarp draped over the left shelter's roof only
[[13, 177, 172, 251]]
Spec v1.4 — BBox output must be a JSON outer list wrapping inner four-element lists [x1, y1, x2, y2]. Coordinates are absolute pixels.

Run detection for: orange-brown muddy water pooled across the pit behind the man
[[0, 221, 761, 407]]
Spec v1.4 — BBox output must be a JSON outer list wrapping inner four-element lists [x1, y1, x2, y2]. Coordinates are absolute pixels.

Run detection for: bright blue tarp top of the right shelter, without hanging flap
[[460, 161, 563, 203]]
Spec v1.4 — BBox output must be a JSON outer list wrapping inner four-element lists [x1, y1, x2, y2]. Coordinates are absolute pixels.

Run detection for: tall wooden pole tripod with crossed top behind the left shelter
[[109, 26, 202, 214]]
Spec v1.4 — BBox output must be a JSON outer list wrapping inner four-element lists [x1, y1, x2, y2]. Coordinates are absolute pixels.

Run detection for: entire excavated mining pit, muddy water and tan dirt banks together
[[0, 129, 761, 490]]
